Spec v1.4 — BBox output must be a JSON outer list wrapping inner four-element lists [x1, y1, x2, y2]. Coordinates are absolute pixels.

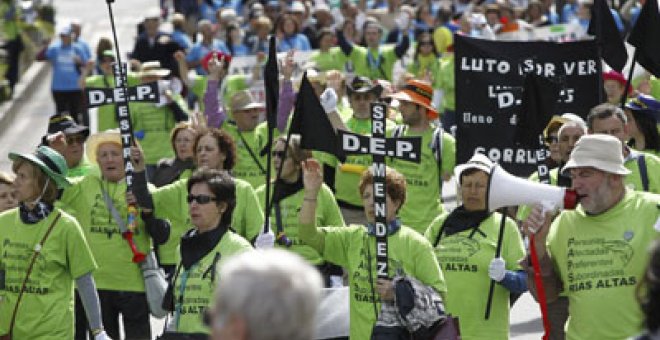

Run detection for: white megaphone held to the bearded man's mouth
[[488, 165, 578, 211]]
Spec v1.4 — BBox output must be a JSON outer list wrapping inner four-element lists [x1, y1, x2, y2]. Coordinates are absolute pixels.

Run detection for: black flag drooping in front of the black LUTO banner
[[515, 73, 559, 148]]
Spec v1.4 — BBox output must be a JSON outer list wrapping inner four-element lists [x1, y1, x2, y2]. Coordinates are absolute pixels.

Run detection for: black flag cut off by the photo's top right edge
[[628, 0, 660, 77]]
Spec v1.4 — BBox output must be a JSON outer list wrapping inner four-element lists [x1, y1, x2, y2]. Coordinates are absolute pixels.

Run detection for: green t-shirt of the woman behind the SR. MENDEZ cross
[[321, 225, 447, 339]]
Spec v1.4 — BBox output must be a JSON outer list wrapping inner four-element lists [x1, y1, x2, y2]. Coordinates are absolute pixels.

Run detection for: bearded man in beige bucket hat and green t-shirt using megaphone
[[523, 134, 660, 340]]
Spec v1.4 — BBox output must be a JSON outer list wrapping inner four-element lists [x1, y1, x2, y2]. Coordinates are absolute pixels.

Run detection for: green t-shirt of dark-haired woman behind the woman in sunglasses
[[150, 178, 264, 265]]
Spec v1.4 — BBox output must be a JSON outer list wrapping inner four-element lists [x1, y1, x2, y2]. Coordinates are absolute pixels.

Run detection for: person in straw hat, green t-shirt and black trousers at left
[[49, 130, 169, 339]]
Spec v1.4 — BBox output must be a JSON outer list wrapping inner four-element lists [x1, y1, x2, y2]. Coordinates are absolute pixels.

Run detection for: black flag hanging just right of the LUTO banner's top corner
[[587, 0, 628, 72]]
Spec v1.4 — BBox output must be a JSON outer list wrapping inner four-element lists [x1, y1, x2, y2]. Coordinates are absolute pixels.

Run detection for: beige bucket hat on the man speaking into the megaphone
[[562, 133, 630, 175]]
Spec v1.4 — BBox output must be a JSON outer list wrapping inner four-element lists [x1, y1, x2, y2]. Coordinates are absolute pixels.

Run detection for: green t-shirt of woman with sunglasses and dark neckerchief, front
[[173, 231, 253, 334]]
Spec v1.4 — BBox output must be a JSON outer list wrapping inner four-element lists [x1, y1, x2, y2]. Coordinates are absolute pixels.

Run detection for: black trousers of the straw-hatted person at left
[[75, 290, 151, 340]]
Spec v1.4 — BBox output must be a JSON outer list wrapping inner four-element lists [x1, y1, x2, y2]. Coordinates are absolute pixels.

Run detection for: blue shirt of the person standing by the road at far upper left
[[46, 40, 88, 91]]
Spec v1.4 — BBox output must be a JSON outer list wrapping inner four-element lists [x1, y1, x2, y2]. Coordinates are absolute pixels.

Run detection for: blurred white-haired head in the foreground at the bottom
[[209, 249, 321, 340]]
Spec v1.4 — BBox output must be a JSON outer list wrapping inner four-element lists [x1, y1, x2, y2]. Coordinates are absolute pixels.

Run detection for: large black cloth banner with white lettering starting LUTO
[[454, 35, 602, 176]]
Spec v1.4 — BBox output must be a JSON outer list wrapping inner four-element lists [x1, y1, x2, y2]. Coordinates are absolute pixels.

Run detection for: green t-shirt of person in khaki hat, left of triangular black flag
[[222, 122, 277, 188]]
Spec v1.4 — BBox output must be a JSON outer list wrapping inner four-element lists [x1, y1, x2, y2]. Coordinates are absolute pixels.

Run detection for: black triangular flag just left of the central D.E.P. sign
[[290, 72, 342, 158]]
